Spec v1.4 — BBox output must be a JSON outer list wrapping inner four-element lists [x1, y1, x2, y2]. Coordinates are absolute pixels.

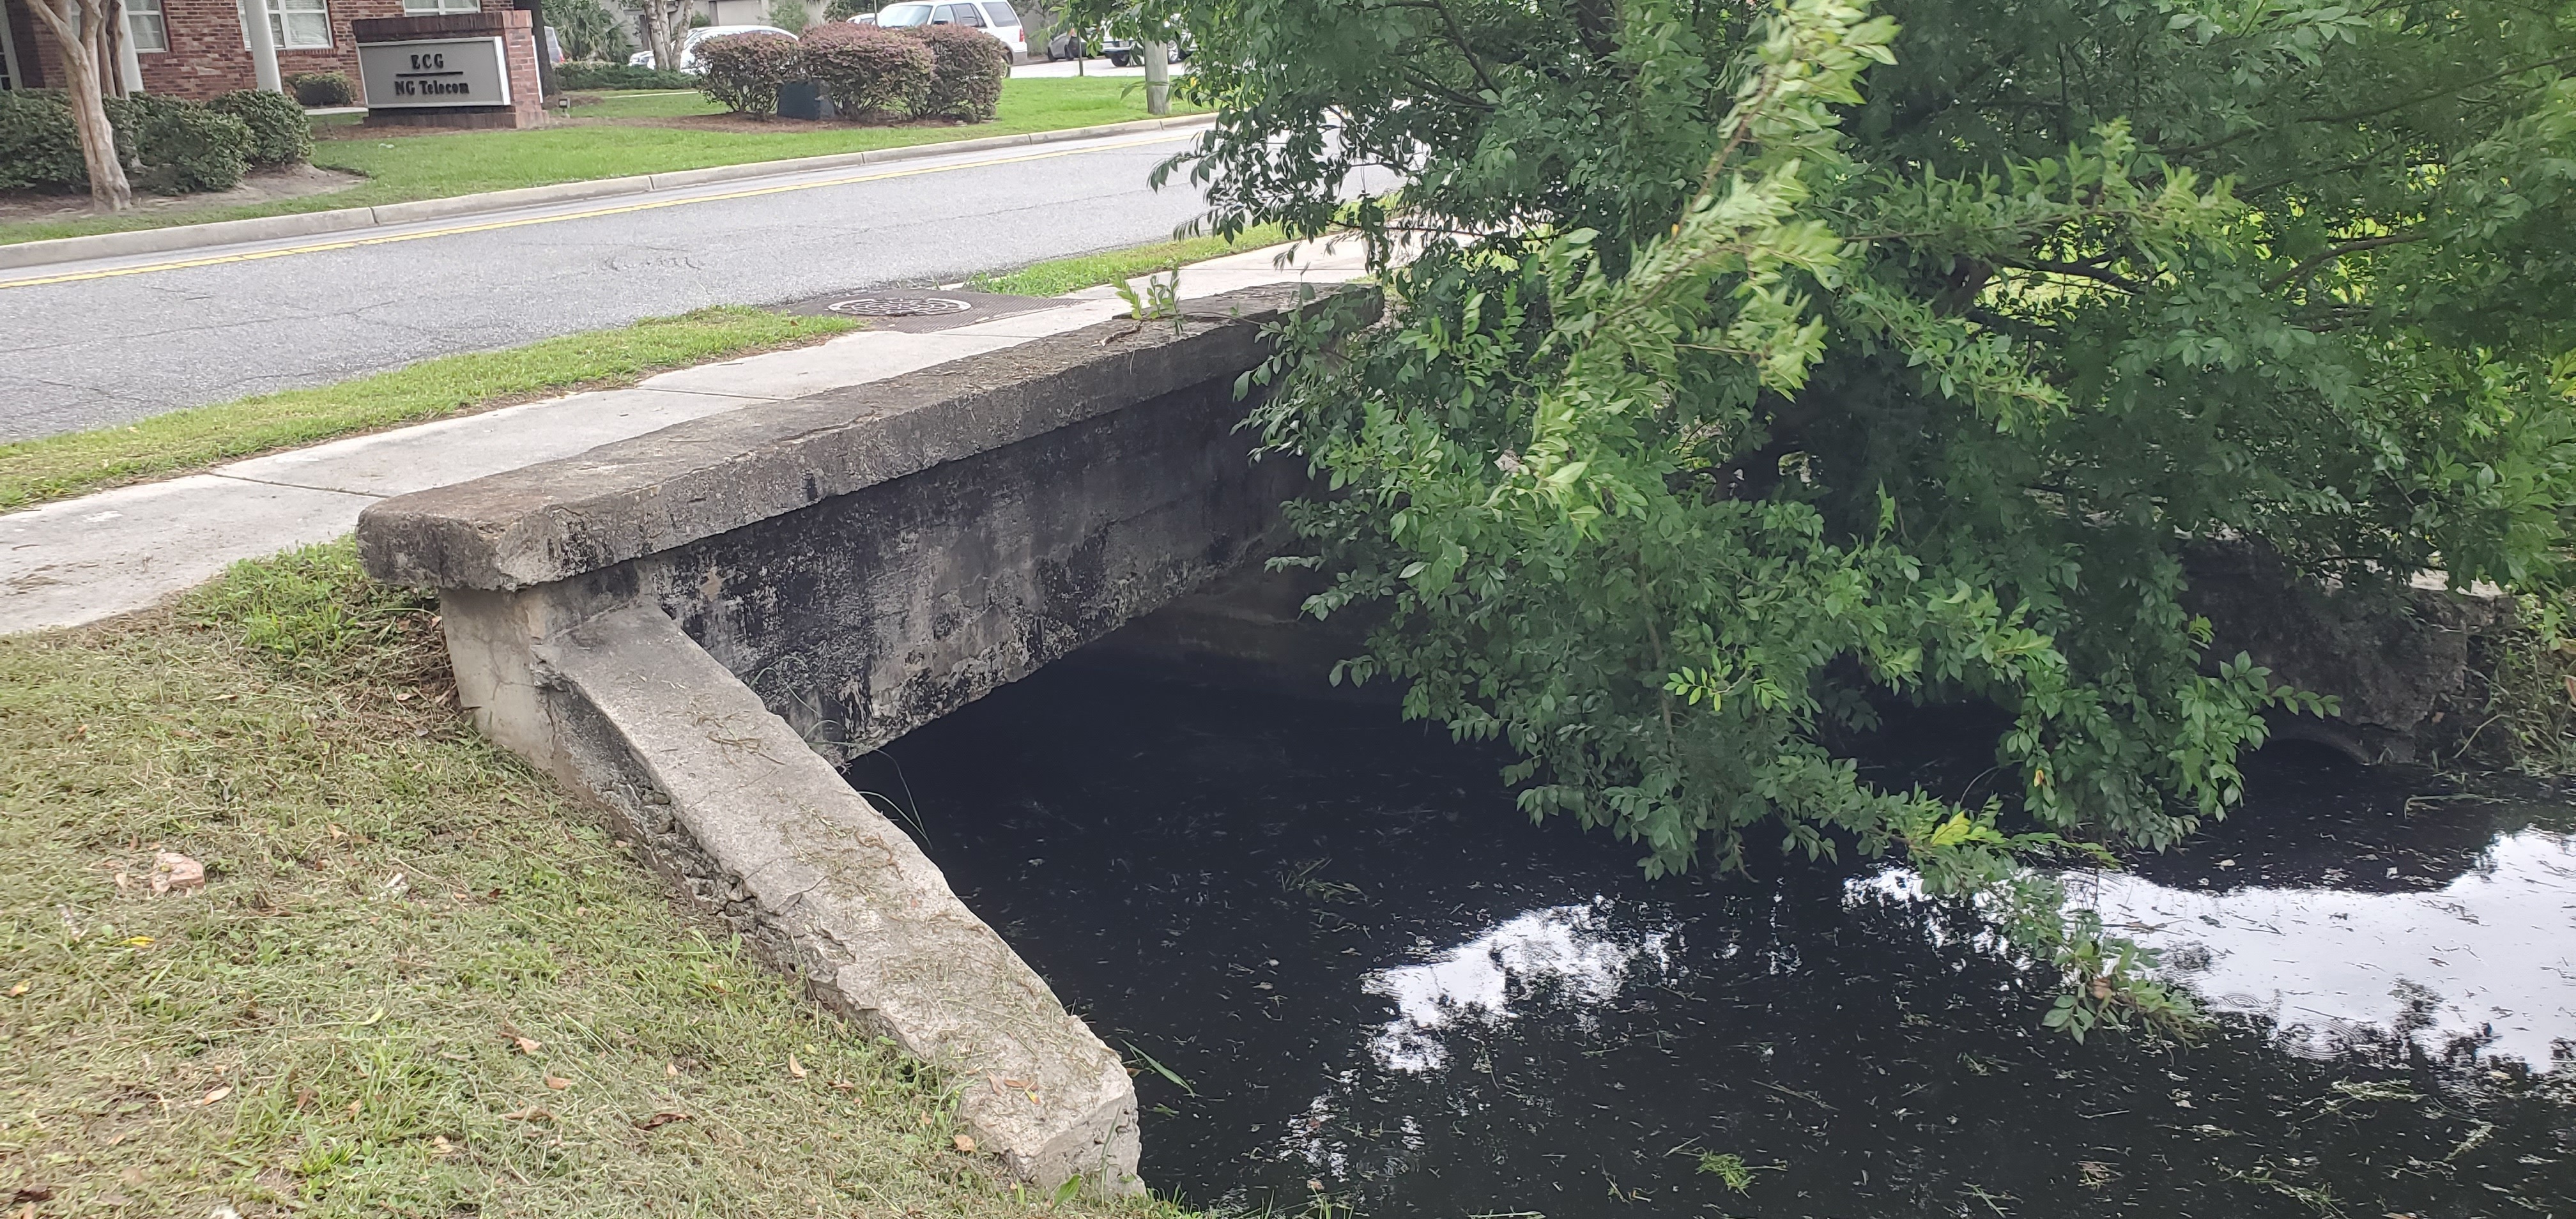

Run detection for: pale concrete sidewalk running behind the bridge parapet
[[0, 242, 1363, 634]]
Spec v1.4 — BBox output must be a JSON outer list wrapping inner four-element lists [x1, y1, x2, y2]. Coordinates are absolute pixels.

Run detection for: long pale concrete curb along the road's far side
[[0, 113, 1216, 271]]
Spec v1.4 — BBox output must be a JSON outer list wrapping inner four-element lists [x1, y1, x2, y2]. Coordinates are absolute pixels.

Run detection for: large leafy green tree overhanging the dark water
[[1146, 0, 2576, 1031]]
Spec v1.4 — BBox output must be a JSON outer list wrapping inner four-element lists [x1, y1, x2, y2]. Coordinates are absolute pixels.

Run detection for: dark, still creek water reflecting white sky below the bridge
[[853, 673, 2576, 1219]]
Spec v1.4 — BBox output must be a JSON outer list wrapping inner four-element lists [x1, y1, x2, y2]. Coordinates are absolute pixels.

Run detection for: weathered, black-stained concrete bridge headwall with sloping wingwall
[[358, 289, 1370, 1191]]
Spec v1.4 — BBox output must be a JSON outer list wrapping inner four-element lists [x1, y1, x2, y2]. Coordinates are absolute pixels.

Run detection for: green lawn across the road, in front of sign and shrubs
[[0, 77, 1188, 245]]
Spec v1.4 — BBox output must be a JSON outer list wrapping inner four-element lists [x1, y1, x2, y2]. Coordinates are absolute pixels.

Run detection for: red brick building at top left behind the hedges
[[0, 0, 492, 100]]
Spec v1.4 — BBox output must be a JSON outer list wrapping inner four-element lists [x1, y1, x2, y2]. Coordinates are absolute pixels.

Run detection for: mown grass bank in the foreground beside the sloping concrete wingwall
[[0, 541, 1154, 1219]]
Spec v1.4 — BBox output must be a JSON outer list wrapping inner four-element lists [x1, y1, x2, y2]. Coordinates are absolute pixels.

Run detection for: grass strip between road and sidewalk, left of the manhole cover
[[0, 307, 855, 510]]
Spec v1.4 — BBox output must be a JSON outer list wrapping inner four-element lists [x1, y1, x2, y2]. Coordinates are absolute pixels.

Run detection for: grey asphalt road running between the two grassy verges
[[0, 132, 1203, 441]]
